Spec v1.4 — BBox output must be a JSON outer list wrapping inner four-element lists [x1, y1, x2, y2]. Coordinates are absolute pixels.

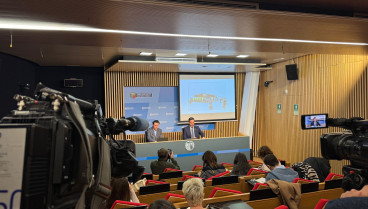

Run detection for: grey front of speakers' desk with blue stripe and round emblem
[[136, 136, 250, 173]]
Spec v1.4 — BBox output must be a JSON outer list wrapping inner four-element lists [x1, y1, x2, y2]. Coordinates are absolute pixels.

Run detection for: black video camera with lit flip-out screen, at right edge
[[302, 114, 368, 191]]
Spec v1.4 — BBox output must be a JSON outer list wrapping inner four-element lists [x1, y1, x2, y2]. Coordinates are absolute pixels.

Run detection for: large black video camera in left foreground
[[0, 83, 148, 209]]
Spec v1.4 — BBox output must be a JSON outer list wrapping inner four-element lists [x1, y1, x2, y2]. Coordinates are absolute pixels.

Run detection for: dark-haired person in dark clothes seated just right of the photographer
[[199, 150, 226, 179]]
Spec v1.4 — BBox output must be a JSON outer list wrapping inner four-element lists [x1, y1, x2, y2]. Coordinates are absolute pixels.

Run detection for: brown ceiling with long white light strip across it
[[0, 0, 368, 66]]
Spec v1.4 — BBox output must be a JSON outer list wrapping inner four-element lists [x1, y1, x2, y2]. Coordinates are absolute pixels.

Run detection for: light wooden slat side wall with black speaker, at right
[[253, 54, 368, 173]]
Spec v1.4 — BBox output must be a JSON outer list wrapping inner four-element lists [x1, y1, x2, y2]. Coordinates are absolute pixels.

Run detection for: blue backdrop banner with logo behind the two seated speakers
[[124, 87, 215, 134]]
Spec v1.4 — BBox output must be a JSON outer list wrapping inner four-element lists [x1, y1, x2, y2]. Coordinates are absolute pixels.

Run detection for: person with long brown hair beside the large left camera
[[105, 177, 139, 209]]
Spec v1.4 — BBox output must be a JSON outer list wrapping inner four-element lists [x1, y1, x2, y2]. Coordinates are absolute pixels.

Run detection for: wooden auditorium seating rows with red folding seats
[[117, 161, 343, 209]]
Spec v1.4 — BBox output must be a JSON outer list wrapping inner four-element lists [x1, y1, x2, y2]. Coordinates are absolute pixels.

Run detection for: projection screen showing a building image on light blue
[[179, 74, 236, 122]]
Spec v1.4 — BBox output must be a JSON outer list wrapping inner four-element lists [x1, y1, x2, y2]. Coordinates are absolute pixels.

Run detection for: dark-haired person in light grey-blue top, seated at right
[[263, 154, 299, 182]]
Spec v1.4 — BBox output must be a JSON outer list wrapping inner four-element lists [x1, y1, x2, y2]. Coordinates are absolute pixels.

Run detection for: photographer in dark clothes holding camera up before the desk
[[151, 148, 180, 174]]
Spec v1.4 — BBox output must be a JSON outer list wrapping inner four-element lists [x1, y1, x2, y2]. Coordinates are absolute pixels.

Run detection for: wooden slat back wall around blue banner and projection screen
[[104, 69, 245, 143]]
